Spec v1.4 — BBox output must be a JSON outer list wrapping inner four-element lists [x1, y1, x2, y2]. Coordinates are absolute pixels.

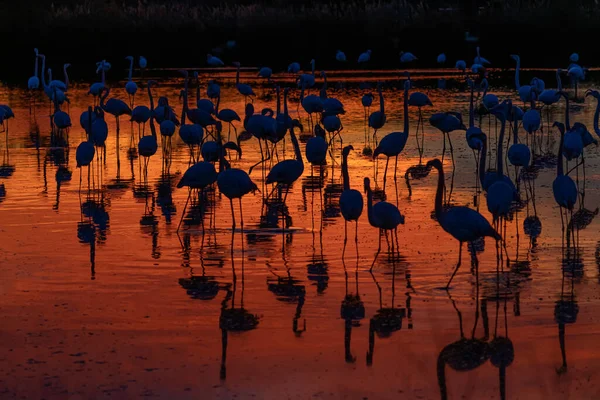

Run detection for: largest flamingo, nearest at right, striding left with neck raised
[[427, 158, 502, 290]]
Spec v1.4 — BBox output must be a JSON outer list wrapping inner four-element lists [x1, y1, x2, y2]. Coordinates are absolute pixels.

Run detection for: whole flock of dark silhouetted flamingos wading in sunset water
[[10, 47, 600, 289]]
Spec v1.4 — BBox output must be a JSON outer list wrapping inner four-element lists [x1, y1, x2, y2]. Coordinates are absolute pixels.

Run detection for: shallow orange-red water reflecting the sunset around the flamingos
[[0, 71, 600, 399]]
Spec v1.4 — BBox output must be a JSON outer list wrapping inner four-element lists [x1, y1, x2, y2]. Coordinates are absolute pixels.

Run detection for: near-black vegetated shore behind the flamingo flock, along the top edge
[[0, 0, 600, 80]]
